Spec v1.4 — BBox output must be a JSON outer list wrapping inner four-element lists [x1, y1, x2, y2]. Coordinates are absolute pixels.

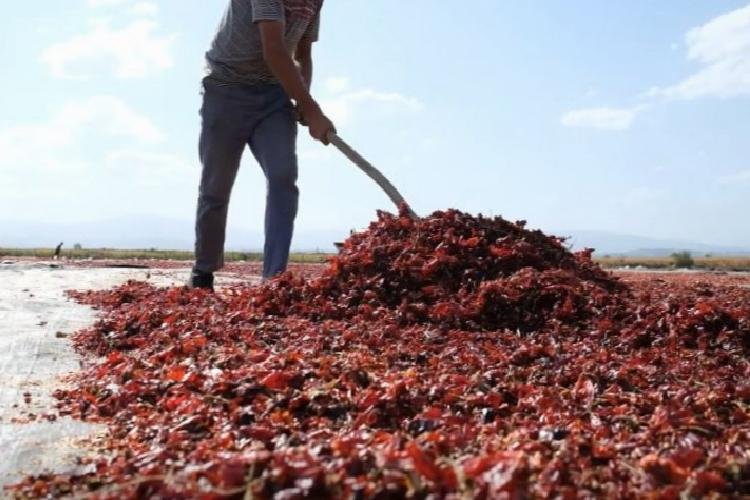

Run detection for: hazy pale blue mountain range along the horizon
[[0, 216, 750, 256]]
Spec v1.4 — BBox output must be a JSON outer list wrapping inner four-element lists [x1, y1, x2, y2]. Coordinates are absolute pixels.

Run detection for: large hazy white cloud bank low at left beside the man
[[0, 96, 187, 211]]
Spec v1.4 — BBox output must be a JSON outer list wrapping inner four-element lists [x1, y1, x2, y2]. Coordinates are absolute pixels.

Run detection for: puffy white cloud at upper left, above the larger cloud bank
[[42, 17, 176, 78]]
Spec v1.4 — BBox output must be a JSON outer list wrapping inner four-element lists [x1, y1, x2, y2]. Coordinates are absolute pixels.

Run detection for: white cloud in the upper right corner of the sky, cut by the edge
[[647, 5, 750, 99]]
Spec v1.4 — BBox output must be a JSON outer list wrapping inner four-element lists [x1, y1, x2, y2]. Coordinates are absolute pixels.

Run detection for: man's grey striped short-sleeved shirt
[[206, 0, 323, 85]]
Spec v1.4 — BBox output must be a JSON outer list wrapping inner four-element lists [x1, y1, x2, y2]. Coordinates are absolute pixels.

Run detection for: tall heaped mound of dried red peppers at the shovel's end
[[249, 210, 622, 331]]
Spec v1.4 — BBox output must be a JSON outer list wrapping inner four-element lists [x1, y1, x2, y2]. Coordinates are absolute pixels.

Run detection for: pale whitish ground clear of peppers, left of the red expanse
[[0, 261, 257, 490]]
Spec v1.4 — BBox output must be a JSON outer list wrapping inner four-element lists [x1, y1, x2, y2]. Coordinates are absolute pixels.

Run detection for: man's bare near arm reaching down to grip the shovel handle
[[258, 21, 334, 144]]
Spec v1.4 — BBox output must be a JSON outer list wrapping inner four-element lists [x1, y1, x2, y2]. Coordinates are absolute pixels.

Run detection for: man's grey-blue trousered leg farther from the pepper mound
[[195, 84, 247, 273]]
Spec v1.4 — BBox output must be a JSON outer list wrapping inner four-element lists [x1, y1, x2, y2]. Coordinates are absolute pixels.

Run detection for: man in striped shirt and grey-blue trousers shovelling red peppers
[[190, 0, 334, 289]]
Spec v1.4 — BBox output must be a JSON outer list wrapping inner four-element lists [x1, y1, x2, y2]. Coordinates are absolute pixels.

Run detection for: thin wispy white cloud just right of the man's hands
[[321, 89, 422, 126]]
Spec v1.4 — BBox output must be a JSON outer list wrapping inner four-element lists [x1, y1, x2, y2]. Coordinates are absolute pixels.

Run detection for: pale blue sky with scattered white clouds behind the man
[[0, 0, 750, 248]]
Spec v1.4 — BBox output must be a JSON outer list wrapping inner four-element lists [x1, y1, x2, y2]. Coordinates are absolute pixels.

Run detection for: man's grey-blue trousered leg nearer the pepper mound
[[250, 100, 299, 278]]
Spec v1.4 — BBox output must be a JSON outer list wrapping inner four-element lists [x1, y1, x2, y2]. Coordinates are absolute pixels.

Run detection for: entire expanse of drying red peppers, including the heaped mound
[[5, 211, 750, 499]]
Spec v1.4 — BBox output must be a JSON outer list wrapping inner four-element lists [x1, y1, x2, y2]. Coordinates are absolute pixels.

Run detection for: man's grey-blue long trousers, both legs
[[195, 80, 299, 278]]
